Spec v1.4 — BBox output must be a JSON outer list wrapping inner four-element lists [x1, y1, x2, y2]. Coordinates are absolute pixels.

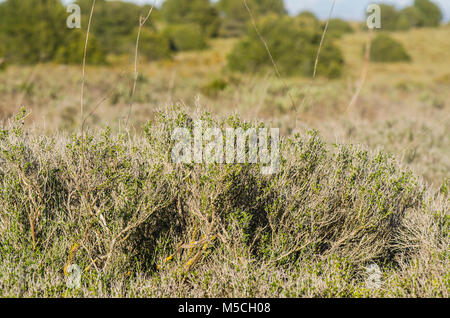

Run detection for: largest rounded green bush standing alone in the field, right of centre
[[228, 15, 343, 78]]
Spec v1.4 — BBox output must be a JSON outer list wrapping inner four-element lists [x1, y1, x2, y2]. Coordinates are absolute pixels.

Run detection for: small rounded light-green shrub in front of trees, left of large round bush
[[164, 24, 207, 51]]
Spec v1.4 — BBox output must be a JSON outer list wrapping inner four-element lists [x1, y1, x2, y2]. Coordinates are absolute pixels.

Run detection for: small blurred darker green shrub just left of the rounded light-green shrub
[[134, 29, 172, 61]]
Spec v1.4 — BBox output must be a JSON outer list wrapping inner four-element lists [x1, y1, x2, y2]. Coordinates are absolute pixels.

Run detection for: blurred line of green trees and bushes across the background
[[0, 0, 442, 77]]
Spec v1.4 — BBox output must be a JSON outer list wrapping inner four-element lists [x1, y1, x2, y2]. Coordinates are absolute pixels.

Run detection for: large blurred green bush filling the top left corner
[[0, 0, 104, 64]]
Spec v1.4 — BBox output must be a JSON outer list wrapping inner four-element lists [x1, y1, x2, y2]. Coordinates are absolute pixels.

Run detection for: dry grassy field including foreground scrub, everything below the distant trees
[[0, 26, 450, 297]]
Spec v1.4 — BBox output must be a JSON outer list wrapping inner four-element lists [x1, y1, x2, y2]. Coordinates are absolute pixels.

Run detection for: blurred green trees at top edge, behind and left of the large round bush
[[216, 0, 286, 37]]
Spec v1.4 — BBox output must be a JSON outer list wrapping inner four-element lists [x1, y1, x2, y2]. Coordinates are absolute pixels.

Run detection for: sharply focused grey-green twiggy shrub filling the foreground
[[0, 110, 449, 297]]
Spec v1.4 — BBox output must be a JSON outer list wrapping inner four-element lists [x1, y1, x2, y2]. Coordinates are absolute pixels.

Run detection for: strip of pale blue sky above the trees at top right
[[61, 0, 450, 21]]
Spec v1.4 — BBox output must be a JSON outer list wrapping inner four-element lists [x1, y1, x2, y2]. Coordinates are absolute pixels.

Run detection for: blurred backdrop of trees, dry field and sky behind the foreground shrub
[[0, 0, 450, 187]]
